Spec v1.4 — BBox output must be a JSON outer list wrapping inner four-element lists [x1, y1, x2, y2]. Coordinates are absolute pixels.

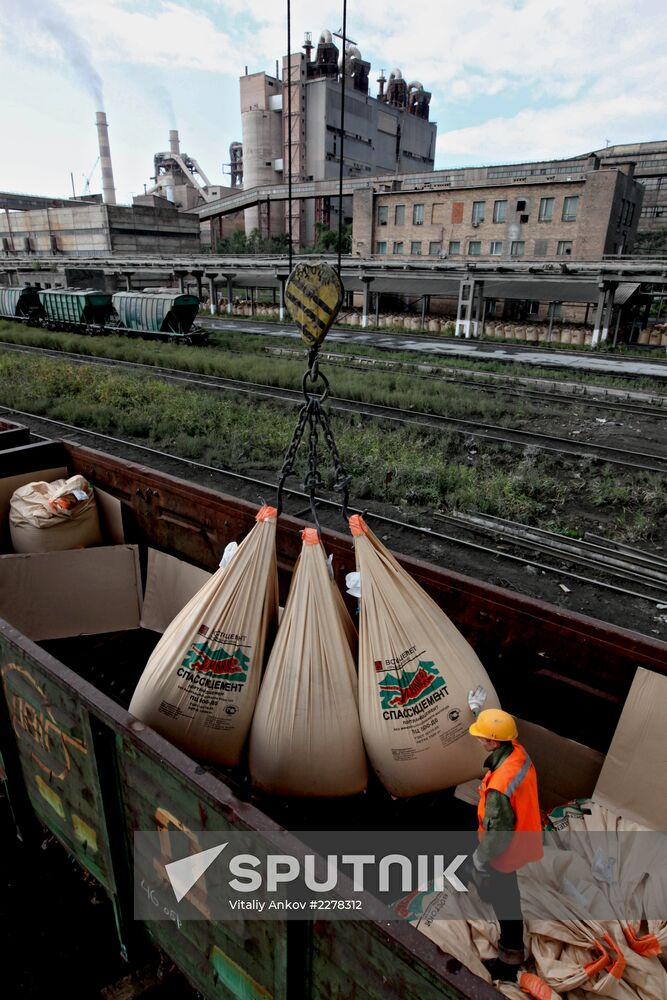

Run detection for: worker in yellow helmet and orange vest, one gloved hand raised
[[460, 700, 544, 981]]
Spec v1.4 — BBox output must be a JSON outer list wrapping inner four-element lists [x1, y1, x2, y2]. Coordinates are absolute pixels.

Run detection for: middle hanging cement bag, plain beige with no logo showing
[[249, 528, 368, 796]]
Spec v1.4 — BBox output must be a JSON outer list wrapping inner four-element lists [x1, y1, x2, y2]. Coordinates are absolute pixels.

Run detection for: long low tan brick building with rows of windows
[[352, 156, 643, 262]]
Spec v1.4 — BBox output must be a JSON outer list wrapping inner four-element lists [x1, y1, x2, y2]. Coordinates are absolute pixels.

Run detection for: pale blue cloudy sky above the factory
[[0, 0, 667, 203]]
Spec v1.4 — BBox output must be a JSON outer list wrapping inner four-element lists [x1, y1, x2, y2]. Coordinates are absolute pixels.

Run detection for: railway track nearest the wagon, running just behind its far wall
[[5, 406, 667, 616]]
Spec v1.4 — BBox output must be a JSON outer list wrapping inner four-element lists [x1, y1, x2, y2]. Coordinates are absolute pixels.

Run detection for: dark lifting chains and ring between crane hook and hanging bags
[[276, 347, 351, 531]]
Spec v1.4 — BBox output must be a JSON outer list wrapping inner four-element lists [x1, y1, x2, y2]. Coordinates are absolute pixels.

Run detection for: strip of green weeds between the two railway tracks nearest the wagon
[[0, 355, 667, 542]]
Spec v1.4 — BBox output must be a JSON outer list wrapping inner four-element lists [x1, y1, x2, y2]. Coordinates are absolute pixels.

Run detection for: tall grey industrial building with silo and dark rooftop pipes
[[240, 31, 437, 246]]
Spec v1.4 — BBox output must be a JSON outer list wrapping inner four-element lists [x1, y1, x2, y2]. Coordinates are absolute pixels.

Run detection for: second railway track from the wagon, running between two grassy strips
[[4, 345, 667, 473]]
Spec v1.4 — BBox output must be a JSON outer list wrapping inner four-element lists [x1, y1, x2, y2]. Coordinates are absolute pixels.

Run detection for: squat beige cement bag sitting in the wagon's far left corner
[[9, 476, 102, 552]]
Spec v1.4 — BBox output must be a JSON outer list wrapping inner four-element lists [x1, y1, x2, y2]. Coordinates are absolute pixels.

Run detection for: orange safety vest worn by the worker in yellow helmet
[[477, 740, 544, 872]]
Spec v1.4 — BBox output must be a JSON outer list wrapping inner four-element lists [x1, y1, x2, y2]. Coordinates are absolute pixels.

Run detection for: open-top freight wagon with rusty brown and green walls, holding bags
[[0, 442, 667, 1000]]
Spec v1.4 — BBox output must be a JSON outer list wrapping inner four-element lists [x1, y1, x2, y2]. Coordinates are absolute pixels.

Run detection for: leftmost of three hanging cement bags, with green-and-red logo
[[130, 506, 278, 766]]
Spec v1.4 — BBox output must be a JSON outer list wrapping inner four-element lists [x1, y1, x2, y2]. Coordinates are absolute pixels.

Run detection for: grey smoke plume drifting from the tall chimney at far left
[[0, 0, 104, 111]]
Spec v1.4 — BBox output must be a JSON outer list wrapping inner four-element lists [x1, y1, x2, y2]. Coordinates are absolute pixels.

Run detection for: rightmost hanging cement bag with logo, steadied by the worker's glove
[[350, 514, 499, 798]]
